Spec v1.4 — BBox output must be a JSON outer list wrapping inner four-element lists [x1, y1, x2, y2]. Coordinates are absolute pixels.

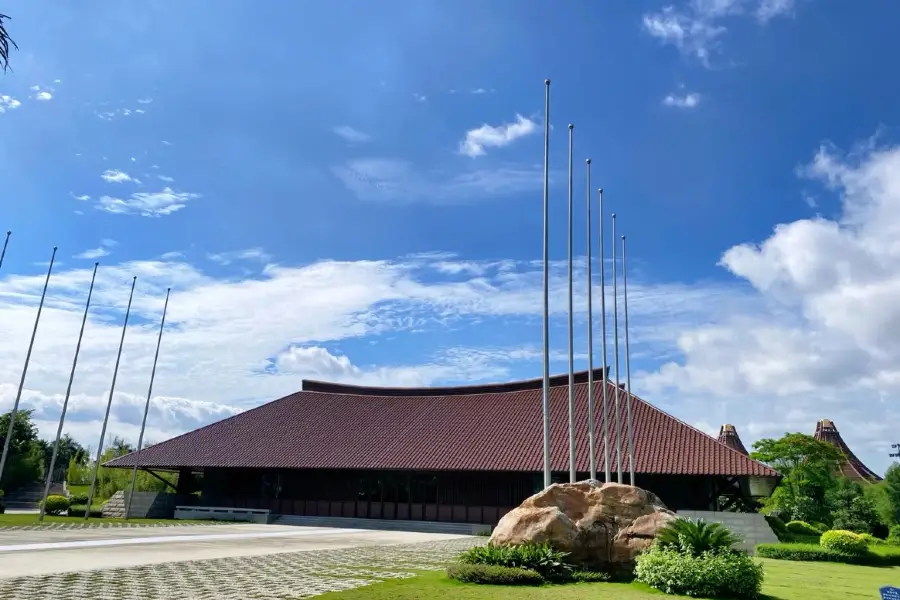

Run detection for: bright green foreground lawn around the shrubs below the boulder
[[319, 559, 900, 600]]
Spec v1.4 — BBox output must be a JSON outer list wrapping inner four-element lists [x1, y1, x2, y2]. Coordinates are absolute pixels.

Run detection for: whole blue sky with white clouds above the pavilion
[[0, 0, 900, 478]]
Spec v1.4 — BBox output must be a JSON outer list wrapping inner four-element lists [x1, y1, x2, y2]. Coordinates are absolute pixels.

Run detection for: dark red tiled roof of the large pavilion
[[106, 370, 777, 477]]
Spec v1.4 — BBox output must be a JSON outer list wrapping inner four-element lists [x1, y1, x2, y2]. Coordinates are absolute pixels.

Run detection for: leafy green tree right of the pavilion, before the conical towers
[[750, 433, 844, 523]]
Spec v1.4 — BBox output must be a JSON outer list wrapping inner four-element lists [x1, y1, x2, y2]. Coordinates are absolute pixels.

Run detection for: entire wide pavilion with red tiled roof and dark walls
[[105, 369, 779, 525]]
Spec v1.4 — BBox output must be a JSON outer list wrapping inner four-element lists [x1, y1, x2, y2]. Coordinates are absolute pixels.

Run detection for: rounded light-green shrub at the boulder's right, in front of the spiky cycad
[[634, 545, 763, 598]]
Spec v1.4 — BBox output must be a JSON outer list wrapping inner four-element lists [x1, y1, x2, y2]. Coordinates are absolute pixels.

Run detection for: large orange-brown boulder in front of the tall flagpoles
[[490, 481, 676, 571]]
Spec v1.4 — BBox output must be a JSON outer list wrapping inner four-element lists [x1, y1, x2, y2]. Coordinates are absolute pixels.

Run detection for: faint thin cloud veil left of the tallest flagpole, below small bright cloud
[[332, 158, 543, 204]]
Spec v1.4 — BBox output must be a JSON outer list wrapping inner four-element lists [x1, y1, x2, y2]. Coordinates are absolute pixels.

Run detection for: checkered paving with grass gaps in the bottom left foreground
[[0, 537, 486, 600]]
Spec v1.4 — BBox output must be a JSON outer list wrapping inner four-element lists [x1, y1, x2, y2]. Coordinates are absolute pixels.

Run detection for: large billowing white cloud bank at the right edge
[[643, 132, 900, 474]]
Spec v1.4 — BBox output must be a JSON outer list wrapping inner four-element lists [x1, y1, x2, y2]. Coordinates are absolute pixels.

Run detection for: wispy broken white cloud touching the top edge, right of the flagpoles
[[642, 0, 794, 66]]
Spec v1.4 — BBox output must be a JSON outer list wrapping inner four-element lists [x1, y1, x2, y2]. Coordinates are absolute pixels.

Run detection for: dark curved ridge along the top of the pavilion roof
[[302, 367, 610, 397]]
